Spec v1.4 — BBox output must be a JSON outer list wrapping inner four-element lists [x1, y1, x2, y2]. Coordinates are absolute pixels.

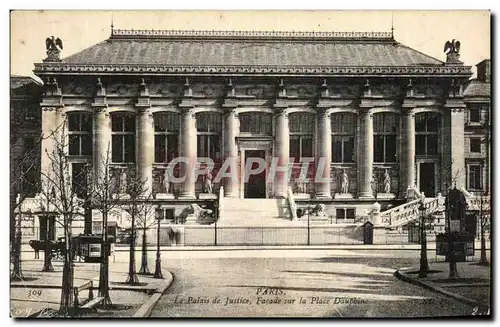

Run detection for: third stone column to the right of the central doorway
[[358, 109, 373, 198]]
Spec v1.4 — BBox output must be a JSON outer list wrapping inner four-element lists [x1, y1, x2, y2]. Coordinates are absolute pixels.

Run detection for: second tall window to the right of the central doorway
[[332, 113, 356, 163]]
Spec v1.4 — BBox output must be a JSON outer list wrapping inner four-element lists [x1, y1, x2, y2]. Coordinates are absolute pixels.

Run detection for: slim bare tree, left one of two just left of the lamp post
[[121, 175, 153, 285]]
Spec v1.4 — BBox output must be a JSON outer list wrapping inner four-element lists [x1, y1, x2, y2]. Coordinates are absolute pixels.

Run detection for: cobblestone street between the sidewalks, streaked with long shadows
[[151, 250, 486, 317]]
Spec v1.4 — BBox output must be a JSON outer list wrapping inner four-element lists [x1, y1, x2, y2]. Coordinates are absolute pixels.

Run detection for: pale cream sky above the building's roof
[[10, 10, 490, 76]]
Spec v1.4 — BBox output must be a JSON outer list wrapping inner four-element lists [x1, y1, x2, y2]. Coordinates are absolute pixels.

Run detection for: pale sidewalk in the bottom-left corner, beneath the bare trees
[[10, 255, 173, 318]]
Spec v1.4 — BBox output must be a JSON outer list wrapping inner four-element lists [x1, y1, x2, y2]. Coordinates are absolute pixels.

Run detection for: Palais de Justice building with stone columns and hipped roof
[[35, 30, 489, 227]]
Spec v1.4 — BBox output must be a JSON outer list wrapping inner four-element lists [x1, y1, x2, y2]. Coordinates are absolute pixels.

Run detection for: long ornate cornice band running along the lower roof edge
[[34, 62, 472, 77]]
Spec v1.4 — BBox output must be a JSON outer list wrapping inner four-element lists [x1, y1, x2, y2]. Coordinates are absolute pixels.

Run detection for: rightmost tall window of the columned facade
[[415, 112, 441, 155]]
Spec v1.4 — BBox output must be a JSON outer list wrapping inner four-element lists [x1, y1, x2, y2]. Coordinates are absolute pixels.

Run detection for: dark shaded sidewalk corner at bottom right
[[394, 258, 491, 315]]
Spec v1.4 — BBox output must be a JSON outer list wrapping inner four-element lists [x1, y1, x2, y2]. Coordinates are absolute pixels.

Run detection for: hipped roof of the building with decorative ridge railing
[[35, 30, 470, 75]]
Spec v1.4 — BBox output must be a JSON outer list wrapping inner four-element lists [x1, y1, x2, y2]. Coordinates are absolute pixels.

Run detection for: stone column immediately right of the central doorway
[[274, 110, 290, 198]]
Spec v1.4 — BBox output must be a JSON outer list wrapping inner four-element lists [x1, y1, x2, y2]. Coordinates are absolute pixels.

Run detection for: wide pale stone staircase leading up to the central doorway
[[218, 198, 291, 226]]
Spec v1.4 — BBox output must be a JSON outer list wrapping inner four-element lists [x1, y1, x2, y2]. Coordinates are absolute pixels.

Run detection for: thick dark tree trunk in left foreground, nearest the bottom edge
[[59, 226, 74, 316]]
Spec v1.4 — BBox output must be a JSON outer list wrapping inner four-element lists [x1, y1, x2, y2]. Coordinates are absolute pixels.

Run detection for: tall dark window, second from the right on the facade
[[373, 112, 399, 163]]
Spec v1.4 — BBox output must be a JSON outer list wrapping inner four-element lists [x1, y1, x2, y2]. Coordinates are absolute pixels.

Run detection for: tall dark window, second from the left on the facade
[[111, 113, 135, 163]]
